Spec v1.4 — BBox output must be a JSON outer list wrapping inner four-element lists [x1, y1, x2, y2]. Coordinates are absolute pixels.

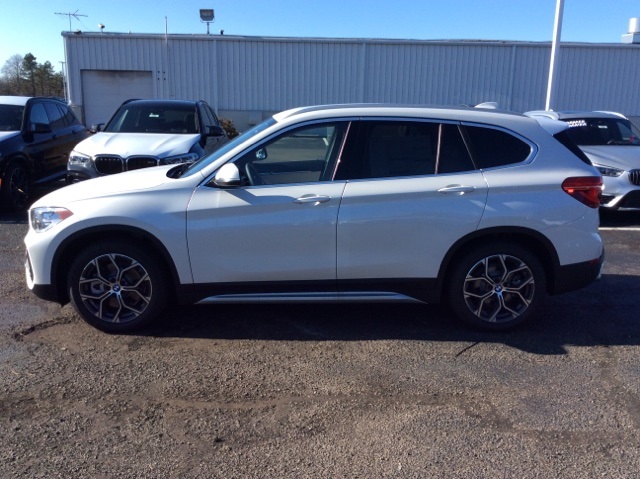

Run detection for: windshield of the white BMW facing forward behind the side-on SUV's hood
[[104, 103, 198, 134]]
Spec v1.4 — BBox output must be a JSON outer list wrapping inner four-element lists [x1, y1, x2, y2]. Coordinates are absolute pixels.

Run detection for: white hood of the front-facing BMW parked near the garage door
[[74, 132, 200, 158]]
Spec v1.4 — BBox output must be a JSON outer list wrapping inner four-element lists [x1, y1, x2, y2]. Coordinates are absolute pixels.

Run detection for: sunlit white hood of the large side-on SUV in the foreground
[[32, 165, 176, 207]]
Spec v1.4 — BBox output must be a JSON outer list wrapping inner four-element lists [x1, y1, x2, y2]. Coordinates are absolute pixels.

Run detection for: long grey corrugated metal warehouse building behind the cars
[[62, 32, 640, 130]]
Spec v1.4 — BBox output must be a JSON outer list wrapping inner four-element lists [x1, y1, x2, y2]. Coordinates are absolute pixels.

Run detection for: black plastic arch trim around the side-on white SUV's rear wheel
[[437, 227, 560, 299]]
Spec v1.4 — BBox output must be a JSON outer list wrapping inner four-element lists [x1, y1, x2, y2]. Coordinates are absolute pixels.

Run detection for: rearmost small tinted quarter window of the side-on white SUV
[[465, 125, 531, 169]]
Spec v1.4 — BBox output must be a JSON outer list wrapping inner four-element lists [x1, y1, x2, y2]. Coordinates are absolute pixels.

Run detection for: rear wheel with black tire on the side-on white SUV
[[446, 243, 546, 331]]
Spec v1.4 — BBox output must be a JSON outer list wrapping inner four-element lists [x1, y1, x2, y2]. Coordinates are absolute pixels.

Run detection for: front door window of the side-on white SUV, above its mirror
[[236, 122, 349, 186]]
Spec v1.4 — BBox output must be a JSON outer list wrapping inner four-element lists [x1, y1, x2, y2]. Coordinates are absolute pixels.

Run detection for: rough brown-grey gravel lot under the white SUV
[[0, 215, 640, 479]]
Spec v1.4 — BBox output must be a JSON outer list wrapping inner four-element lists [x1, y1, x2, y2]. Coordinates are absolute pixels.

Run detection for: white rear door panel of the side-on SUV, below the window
[[337, 172, 487, 280]]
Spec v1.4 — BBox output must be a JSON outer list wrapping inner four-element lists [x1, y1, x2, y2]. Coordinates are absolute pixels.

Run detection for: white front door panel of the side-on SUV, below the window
[[187, 182, 345, 283]]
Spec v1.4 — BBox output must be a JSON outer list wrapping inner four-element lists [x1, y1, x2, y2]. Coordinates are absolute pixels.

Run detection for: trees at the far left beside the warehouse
[[0, 53, 65, 98]]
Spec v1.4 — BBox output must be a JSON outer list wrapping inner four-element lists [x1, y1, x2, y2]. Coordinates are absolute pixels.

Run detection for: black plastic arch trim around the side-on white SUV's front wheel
[[51, 225, 179, 304]]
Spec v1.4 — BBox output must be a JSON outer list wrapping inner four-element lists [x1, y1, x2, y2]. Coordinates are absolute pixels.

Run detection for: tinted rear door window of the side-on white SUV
[[338, 121, 474, 179]]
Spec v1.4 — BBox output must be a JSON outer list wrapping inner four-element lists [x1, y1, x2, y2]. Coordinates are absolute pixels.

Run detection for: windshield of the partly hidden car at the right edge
[[564, 118, 640, 146]]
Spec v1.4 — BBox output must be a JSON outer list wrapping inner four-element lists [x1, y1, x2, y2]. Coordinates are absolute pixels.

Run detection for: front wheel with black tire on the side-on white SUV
[[67, 241, 168, 333]]
